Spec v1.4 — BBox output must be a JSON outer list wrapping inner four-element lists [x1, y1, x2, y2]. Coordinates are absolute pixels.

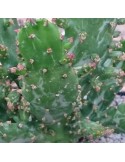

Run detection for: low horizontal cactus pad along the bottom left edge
[[0, 121, 76, 143]]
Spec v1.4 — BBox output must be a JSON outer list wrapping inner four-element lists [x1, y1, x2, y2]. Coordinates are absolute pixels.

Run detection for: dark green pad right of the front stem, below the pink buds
[[80, 62, 124, 116]]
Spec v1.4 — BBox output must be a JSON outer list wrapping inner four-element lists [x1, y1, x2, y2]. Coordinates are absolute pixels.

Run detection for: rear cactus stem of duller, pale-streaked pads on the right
[[56, 19, 125, 135]]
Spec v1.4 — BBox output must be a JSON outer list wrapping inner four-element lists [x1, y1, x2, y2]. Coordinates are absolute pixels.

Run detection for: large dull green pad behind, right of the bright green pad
[[58, 19, 115, 66]]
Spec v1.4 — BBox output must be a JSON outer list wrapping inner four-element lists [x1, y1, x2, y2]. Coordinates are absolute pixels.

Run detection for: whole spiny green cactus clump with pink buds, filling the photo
[[0, 19, 124, 142]]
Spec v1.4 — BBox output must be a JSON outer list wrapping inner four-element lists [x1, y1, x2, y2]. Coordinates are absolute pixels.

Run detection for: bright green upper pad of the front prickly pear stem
[[19, 20, 64, 71]]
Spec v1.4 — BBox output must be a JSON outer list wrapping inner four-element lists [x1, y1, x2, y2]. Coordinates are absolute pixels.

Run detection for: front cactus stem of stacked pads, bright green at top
[[15, 19, 110, 142]]
